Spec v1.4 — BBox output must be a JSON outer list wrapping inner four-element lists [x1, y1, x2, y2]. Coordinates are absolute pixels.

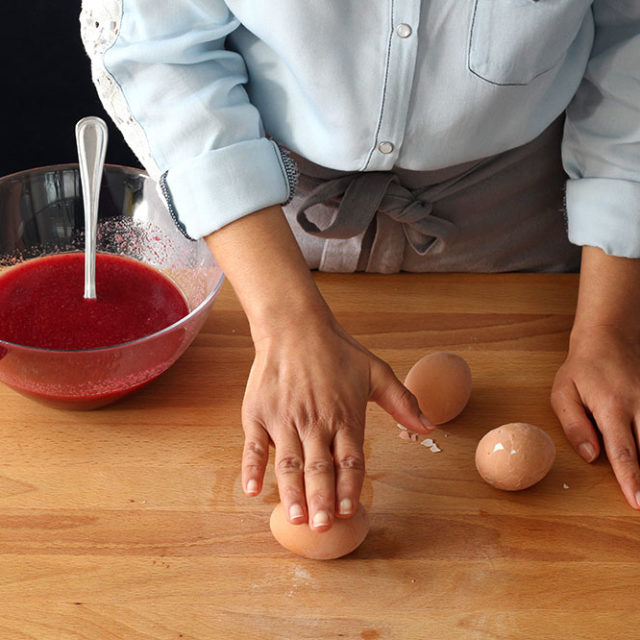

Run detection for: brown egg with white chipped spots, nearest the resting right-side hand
[[476, 422, 556, 491]]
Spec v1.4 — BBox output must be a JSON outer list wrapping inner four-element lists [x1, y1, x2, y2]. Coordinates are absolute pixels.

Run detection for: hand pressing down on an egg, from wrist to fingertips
[[242, 314, 432, 530]]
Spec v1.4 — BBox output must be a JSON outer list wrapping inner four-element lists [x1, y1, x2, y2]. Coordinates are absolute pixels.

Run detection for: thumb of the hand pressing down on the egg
[[369, 360, 435, 433]]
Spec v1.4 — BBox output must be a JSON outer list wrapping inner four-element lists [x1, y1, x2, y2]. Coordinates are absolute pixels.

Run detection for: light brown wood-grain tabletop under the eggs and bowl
[[0, 274, 640, 640]]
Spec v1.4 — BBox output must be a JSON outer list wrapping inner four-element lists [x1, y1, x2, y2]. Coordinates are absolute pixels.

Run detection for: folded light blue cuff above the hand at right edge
[[567, 178, 640, 258]]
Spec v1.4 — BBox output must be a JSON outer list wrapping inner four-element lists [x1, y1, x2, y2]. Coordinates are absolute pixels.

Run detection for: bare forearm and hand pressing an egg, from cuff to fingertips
[[206, 207, 430, 530]]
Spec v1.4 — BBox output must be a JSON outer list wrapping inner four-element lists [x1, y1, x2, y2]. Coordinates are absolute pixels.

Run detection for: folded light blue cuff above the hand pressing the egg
[[161, 138, 296, 239]]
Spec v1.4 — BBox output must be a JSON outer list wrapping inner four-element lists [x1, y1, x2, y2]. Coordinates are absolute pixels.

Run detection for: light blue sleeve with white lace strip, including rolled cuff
[[81, 0, 295, 238]]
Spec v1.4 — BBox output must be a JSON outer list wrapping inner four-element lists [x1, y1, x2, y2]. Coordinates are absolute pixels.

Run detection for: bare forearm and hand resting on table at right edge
[[551, 246, 640, 509]]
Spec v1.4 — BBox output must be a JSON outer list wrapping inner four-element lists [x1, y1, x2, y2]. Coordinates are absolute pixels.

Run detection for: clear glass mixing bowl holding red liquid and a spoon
[[0, 164, 224, 409]]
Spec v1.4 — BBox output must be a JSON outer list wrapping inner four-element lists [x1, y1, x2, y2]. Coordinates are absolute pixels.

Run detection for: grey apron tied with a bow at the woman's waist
[[285, 118, 580, 273]]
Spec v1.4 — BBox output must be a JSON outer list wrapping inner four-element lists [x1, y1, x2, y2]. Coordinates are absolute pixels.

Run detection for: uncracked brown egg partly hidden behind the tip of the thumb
[[404, 351, 471, 424]]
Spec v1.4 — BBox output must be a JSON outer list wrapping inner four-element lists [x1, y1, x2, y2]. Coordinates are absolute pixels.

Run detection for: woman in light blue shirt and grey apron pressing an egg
[[81, 0, 640, 530]]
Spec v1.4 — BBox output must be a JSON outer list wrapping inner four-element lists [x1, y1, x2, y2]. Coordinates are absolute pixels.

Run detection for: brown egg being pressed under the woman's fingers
[[269, 502, 369, 560]]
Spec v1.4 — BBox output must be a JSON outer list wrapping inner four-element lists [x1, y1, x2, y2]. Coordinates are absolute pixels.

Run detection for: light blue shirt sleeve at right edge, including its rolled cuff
[[563, 0, 640, 258]]
